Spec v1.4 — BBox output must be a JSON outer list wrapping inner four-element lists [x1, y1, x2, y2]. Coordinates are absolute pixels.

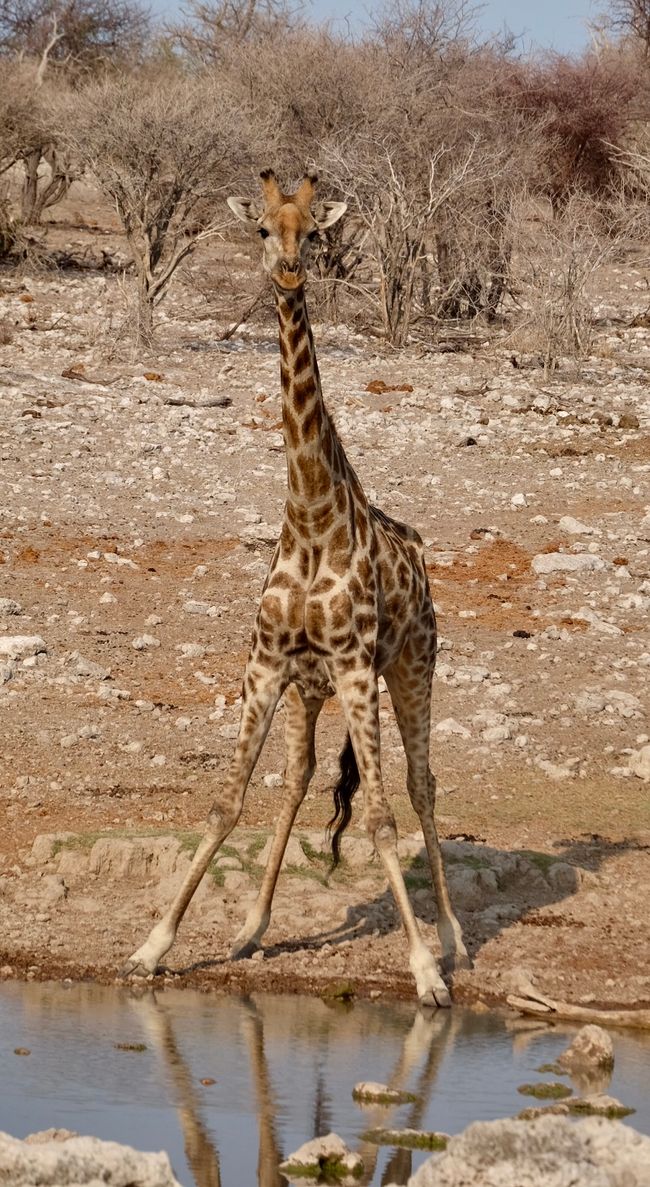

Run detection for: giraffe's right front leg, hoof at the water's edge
[[331, 662, 451, 1007]]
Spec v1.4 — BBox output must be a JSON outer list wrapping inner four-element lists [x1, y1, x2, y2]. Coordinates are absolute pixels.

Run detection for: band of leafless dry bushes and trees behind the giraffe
[[0, 0, 650, 348]]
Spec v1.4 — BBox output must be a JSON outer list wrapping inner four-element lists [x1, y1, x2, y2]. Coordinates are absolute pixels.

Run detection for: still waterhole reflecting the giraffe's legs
[[0, 984, 650, 1187]]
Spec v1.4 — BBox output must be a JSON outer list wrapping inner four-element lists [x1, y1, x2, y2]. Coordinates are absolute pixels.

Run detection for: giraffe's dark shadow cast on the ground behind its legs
[[257, 834, 650, 973]]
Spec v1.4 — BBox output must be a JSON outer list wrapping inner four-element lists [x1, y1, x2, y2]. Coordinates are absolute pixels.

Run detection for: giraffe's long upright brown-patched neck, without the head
[[275, 288, 349, 509]]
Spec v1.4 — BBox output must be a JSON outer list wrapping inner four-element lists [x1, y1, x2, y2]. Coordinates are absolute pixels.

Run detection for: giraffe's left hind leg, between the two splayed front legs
[[230, 685, 323, 960]]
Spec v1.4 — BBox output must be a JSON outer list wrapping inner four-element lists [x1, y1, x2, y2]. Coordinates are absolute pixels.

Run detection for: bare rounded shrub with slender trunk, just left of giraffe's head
[[58, 72, 247, 342]]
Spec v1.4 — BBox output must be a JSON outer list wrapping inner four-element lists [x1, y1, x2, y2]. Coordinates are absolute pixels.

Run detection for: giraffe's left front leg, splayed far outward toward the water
[[122, 656, 285, 976]]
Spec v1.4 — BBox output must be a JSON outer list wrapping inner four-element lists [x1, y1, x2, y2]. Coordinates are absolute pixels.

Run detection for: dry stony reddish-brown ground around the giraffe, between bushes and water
[[0, 194, 650, 1007]]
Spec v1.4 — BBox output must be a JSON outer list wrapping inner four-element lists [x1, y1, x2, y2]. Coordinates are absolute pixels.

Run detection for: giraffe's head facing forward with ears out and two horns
[[228, 169, 346, 291]]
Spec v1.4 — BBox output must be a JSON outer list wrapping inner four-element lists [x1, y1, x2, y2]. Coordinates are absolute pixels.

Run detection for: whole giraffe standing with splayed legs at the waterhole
[[123, 170, 470, 1007]]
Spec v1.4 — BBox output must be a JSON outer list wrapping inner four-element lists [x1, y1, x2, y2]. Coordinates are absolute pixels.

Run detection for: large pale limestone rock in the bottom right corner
[[408, 1116, 650, 1187]]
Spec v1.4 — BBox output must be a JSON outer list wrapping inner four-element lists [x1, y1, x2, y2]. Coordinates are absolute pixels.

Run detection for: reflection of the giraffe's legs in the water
[[132, 992, 460, 1187]]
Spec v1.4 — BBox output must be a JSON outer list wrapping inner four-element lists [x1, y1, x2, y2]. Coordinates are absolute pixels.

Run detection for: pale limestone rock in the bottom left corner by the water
[[0, 1134, 180, 1187]]
